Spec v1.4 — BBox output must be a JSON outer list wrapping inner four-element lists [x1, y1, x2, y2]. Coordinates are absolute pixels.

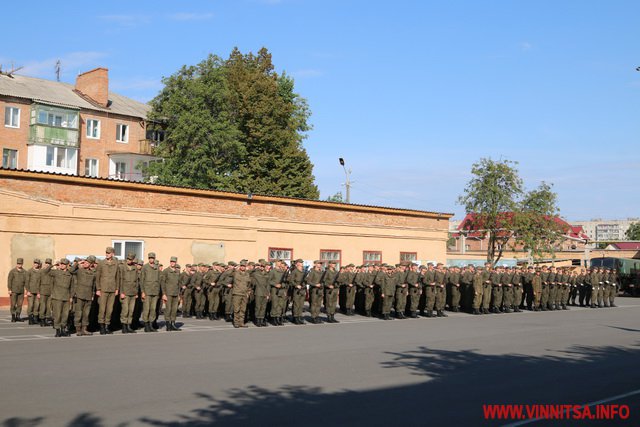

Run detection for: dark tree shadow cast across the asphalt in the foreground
[[2, 344, 640, 427]]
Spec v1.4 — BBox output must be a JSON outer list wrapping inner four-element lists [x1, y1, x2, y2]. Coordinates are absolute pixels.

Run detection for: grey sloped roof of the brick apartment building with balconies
[[0, 74, 151, 119]]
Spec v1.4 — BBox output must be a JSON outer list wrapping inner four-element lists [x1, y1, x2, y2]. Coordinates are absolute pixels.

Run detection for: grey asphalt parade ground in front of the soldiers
[[0, 298, 640, 427]]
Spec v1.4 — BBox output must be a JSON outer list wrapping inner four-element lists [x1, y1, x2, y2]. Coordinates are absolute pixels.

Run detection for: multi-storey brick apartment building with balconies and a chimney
[[0, 68, 163, 181]]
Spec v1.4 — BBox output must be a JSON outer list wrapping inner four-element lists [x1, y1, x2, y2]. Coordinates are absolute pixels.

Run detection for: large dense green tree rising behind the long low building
[[147, 48, 319, 199]]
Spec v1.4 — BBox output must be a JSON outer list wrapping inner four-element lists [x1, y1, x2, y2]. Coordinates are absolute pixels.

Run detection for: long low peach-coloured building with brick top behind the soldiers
[[0, 168, 452, 303]]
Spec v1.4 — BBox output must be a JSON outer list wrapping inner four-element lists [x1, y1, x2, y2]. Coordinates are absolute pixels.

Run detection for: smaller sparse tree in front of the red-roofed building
[[458, 158, 566, 264]]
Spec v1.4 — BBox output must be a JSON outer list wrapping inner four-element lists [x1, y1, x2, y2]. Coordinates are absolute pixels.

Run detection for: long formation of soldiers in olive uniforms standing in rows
[[3, 248, 618, 336]]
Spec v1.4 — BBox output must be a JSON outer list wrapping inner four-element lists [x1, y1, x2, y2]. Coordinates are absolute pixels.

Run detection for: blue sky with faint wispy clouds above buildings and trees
[[0, 0, 640, 220]]
